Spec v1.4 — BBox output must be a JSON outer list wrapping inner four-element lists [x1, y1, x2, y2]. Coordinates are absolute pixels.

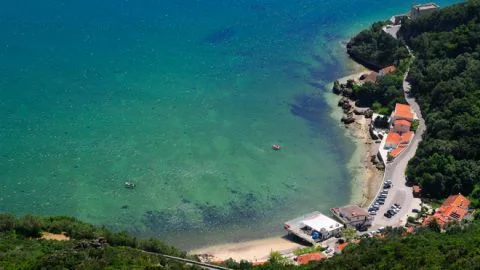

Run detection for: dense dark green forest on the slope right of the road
[[401, 0, 480, 204]]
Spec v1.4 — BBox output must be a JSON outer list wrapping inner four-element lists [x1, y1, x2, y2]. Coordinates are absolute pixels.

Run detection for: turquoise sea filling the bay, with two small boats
[[0, 0, 464, 248]]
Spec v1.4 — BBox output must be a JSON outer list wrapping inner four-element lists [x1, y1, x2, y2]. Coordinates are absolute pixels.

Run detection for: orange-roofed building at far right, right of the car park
[[423, 194, 470, 229]]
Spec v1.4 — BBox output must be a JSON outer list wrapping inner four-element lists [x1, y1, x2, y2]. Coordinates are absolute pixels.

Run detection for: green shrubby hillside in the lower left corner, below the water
[[0, 214, 200, 269]]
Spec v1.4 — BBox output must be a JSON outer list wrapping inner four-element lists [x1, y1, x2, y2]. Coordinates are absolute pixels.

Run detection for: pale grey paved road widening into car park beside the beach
[[372, 68, 425, 230]]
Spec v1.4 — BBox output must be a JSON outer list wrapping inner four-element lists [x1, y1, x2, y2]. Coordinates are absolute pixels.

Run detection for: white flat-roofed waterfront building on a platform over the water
[[284, 211, 343, 245]]
